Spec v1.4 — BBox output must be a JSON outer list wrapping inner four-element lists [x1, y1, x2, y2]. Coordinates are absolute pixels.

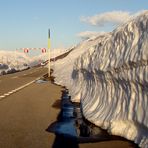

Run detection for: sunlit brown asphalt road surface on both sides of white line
[[0, 68, 61, 148]]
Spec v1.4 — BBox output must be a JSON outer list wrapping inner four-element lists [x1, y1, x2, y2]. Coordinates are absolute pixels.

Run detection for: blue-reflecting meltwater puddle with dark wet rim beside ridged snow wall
[[46, 91, 109, 143]]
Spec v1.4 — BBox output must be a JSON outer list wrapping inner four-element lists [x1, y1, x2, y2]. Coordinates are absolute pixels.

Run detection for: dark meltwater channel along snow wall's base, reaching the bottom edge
[[47, 90, 139, 148]]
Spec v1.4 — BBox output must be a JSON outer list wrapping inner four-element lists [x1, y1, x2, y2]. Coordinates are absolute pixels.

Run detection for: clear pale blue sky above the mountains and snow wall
[[0, 0, 148, 50]]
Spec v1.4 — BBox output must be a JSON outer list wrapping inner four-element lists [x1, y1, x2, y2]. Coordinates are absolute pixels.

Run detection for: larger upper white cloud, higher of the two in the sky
[[80, 11, 132, 27]]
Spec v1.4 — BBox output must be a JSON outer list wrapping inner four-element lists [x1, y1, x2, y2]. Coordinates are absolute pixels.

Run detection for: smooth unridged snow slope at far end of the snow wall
[[53, 34, 109, 86]]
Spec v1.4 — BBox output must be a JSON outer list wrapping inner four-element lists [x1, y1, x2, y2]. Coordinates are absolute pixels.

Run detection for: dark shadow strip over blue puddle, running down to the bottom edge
[[46, 91, 79, 148]]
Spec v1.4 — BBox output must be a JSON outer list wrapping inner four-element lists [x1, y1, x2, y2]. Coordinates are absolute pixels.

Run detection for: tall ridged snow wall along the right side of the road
[[54, 11, 148, 148]]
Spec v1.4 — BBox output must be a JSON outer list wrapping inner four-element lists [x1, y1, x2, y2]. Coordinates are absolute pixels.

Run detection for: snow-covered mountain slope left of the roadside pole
[[0, 51, 47, 75]]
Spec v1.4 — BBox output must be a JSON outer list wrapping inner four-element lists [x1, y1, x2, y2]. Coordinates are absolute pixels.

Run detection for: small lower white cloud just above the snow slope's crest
[[77, 31, 105, 39]]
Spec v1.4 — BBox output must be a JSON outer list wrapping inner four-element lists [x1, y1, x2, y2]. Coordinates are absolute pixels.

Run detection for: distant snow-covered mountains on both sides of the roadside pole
[[0, 48, 71, 75]]
